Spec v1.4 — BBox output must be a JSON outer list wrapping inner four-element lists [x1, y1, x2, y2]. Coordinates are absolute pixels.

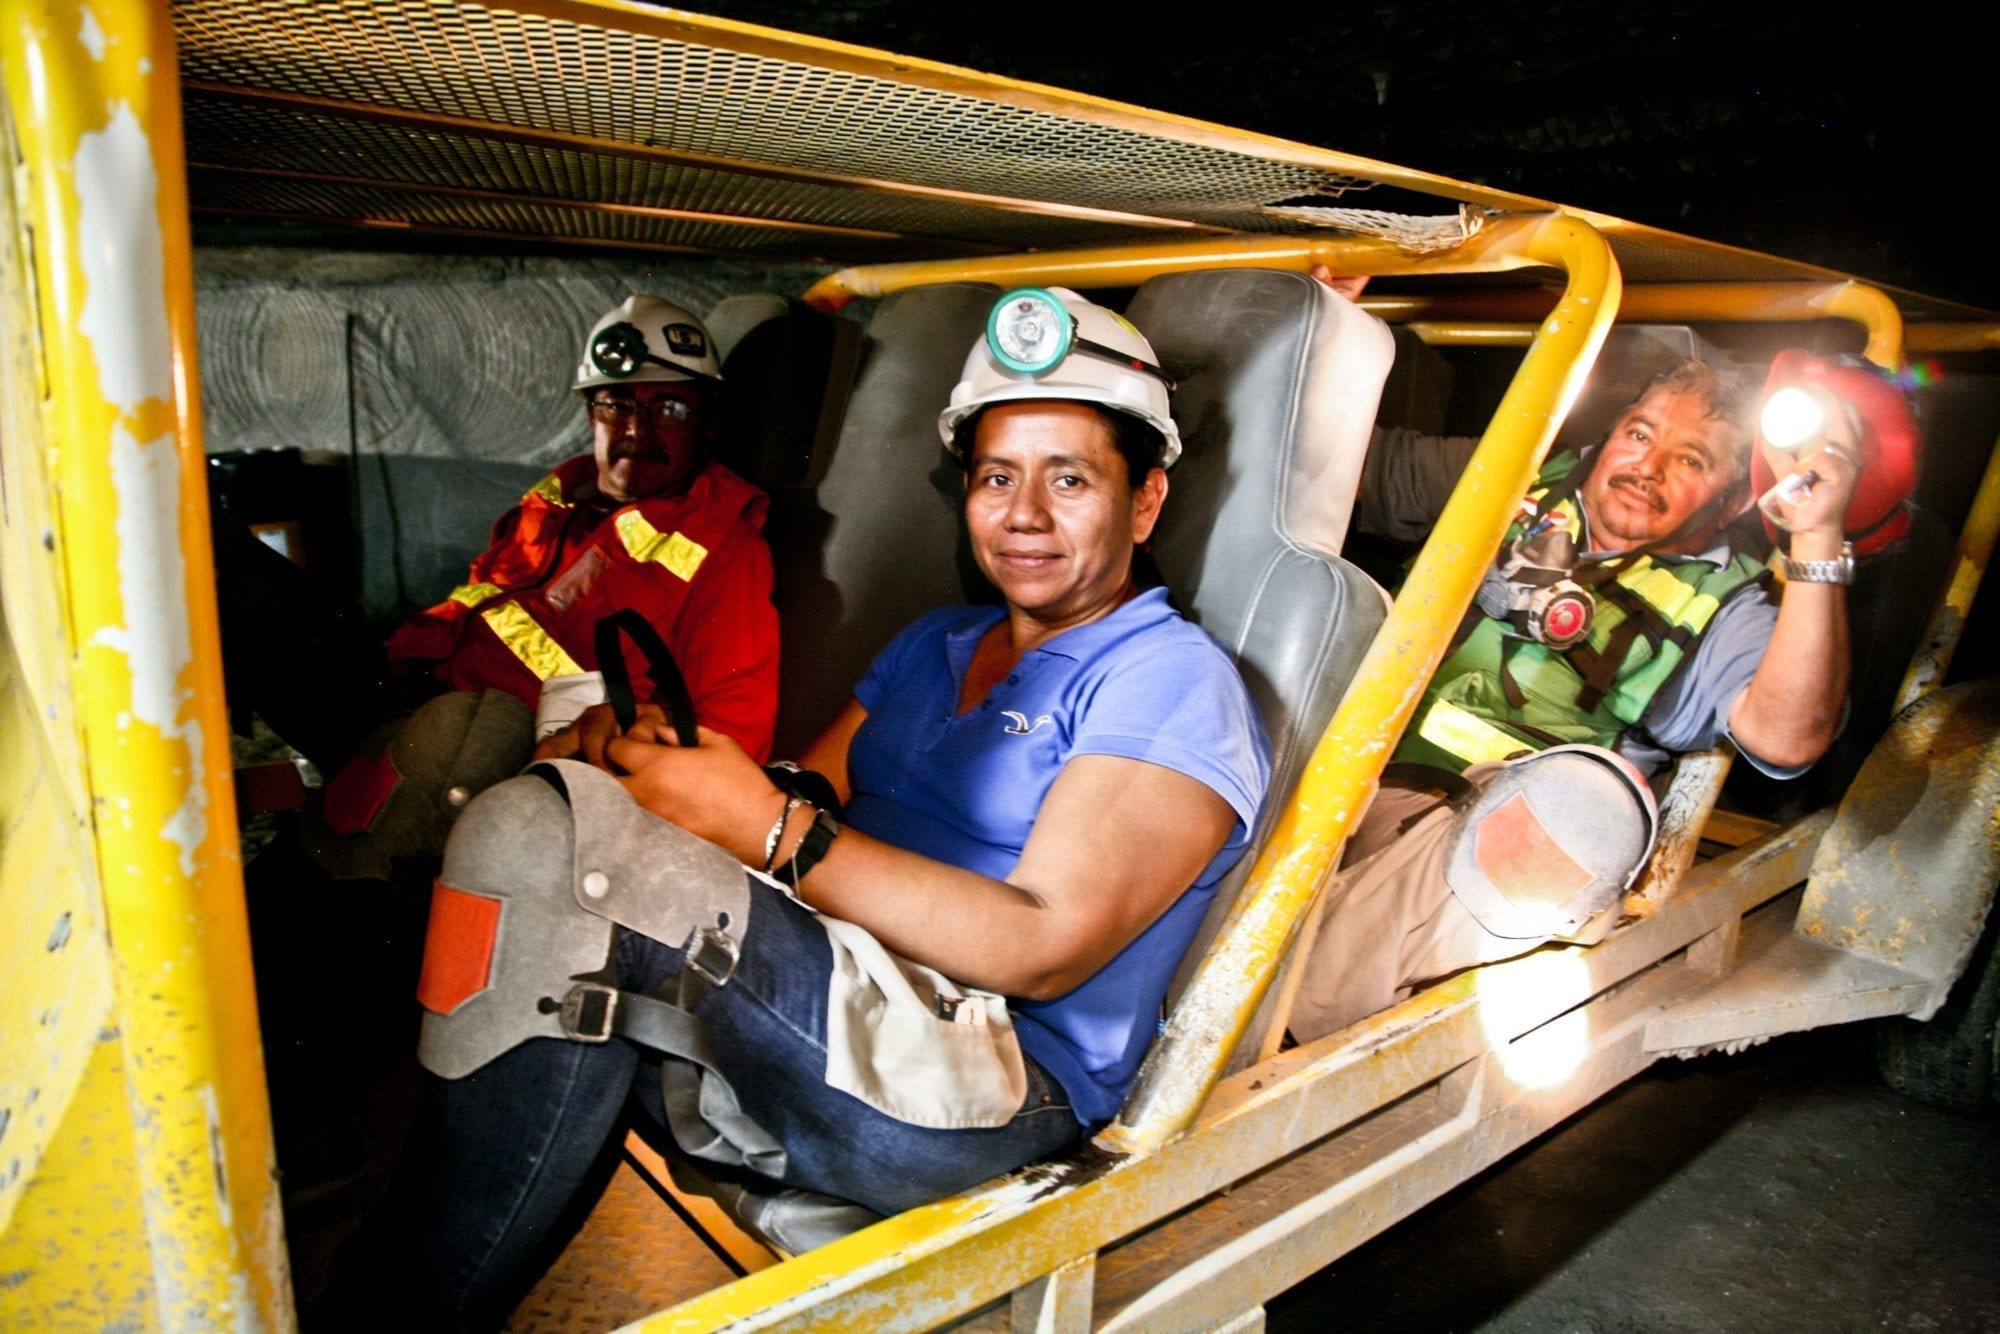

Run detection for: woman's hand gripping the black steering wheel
[[604, 724, 786, 866]]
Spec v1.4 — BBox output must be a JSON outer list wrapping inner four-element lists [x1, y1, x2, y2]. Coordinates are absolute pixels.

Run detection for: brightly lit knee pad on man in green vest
[[1444, 746, 1660, 940]]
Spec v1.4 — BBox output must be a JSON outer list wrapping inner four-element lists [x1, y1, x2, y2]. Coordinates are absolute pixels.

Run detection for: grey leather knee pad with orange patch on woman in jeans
[[418, 760, 750, 1078]]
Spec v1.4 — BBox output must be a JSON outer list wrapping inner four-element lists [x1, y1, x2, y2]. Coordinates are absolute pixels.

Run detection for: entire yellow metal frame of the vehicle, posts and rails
[[0, 0, 2000, 1328]]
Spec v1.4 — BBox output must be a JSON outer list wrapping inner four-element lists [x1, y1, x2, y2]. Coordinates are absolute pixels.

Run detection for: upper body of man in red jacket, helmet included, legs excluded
[[388, 296, 778, 758]]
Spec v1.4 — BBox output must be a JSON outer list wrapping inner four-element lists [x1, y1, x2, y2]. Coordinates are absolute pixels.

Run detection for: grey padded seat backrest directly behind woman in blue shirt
[[1128, 270, 1394, 1012]]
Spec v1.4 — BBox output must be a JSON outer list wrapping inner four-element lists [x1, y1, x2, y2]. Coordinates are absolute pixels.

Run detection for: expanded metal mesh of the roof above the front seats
[[174, 0, 1368, 254]]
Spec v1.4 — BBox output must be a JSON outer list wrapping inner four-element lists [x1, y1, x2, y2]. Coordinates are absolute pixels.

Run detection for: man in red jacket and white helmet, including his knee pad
[[306, 296, 778, 876]]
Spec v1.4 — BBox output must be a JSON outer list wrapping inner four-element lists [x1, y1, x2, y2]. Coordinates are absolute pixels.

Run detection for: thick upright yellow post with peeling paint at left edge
[[0, 0, 290, 1330]]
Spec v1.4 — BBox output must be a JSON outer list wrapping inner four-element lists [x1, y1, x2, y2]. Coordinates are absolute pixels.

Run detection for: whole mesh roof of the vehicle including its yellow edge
[[170, 0, 1968, 310]]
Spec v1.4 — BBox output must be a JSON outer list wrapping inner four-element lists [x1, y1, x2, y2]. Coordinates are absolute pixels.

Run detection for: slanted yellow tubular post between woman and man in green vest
[[1098, 214, 1622, 1152]]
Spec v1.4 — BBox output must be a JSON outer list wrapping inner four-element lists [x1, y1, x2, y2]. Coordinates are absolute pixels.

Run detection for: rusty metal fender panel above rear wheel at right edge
[[1796, 678, 2000, 1020]]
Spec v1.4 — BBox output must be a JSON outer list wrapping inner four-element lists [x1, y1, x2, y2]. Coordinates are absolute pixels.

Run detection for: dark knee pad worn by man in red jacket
[[300, 690, 534, 880]]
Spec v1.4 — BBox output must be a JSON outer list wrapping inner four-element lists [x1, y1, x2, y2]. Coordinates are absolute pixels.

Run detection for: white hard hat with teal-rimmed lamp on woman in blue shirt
[[938, 288, 1180, 468]]
